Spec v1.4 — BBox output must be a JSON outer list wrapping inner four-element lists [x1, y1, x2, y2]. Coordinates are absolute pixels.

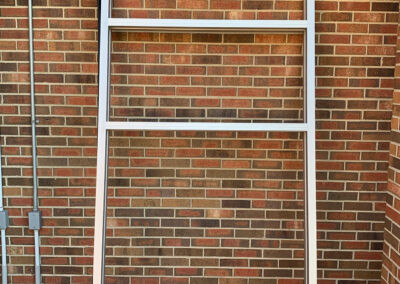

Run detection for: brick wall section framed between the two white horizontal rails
[[110, 32, 304, 122]]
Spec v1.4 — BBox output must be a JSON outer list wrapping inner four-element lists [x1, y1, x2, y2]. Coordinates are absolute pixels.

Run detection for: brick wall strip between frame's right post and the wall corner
[[316, 1, 398, 283]]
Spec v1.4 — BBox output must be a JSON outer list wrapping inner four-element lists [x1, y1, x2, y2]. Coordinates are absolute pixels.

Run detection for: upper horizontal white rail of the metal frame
[[108, 18, 308, 32]]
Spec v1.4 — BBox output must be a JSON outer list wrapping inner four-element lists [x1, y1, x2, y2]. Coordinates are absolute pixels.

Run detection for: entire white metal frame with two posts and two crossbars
[[93, 0, 317, 284]]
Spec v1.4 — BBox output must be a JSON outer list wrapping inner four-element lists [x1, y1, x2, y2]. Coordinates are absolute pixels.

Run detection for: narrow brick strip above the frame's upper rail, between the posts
[[112, 0, 303, 20]]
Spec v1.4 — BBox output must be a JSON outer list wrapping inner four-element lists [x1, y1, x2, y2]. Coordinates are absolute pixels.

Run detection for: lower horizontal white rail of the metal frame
[[105, 121, 309, 132]]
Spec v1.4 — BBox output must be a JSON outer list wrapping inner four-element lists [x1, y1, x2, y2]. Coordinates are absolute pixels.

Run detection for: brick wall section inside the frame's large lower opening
[[106, 131, 304, 283]]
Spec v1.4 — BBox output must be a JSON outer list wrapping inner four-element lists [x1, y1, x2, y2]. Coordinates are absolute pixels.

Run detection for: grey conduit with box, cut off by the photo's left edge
[[0, 145, 8, 284]]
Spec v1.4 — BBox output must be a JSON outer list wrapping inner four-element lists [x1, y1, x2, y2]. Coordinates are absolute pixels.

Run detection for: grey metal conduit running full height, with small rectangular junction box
[[28, 0, 41, 284]]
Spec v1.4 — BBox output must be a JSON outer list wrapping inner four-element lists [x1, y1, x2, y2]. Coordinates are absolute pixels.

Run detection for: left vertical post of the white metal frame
[[93, 0, 110, 284]]
